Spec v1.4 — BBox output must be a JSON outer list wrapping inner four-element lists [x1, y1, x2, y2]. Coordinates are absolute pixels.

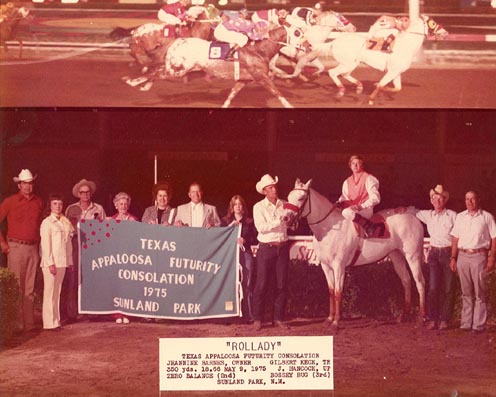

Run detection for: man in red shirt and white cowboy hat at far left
[[0, 169, 43, 332]]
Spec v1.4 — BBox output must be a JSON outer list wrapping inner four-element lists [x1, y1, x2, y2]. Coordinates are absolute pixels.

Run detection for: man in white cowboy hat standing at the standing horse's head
[[253, 174, 289, 331]]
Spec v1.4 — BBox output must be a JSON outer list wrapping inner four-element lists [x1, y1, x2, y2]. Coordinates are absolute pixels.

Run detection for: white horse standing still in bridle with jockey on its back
[[285, 179, 425, 331]]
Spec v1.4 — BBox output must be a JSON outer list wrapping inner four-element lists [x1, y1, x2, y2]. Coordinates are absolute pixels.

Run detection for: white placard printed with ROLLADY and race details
[[159, 336, 334, 391]]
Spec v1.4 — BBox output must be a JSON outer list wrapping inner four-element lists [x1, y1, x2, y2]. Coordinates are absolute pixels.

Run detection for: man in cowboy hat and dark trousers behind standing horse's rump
[[415, 185, 456, 331]]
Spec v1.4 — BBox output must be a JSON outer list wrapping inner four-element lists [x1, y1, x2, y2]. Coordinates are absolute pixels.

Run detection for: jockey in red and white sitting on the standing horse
[[336, 155, 384, 237]]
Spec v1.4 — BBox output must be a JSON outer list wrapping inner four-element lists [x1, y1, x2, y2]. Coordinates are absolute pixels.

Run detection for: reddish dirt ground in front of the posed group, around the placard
[[0, 312, 496, 397]]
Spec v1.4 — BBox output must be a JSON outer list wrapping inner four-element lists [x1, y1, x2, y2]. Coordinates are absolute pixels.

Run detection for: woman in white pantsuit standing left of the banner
[[40, 194, 75, 331]]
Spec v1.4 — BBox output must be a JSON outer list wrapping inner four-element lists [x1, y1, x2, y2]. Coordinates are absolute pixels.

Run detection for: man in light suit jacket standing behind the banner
[[174, 182, 220, 229]]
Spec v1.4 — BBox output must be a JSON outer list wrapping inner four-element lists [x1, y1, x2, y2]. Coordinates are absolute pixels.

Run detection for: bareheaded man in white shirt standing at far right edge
[[450, 191, 496, 333]]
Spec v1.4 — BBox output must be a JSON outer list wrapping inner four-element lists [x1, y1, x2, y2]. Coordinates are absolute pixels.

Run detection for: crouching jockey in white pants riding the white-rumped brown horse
[[214, 9, 267, 60]]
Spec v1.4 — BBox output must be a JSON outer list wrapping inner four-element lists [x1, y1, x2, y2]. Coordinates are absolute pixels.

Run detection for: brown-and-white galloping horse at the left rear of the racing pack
[[110, 4, 219, 73]]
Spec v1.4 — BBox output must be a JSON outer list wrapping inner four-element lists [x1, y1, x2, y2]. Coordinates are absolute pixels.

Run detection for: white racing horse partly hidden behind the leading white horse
[[270, 11, 356, 76]]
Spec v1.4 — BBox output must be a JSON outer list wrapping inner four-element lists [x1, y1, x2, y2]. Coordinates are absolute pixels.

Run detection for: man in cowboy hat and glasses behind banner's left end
[[60, 179, 106, 322]]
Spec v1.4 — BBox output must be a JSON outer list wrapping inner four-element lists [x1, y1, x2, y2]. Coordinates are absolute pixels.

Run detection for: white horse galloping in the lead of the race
[[289, 15, 448, 105]]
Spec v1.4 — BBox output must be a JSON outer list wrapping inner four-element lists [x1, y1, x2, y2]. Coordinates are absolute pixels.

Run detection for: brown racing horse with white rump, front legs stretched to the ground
[[165, 26, 293, 108]]
